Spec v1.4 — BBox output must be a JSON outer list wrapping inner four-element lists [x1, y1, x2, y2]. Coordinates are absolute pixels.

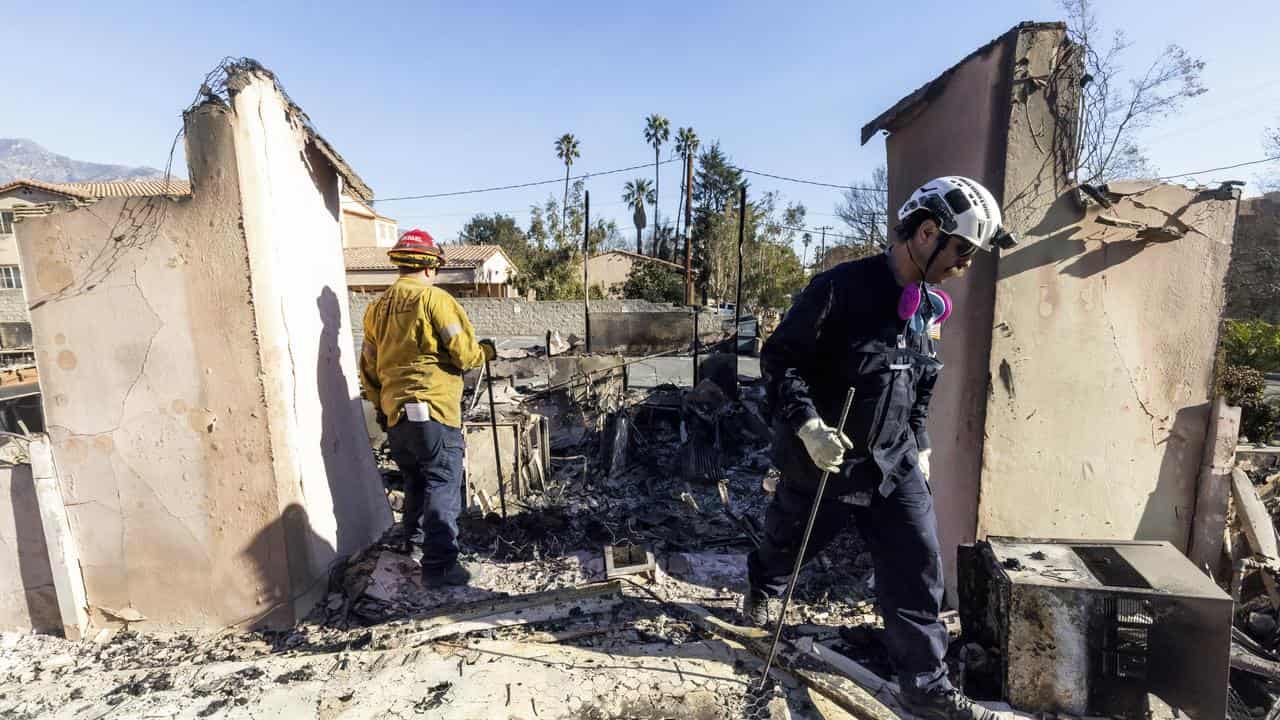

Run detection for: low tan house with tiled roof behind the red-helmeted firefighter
[[343, 245, 518, 297]]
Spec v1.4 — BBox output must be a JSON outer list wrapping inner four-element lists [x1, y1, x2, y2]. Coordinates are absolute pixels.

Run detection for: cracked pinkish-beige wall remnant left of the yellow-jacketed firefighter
[[18, 68, 389, 628]]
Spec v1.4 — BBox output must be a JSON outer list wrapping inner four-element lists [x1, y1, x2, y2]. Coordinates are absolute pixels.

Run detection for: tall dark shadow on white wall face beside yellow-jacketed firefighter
[[316, 286, 389, 553]]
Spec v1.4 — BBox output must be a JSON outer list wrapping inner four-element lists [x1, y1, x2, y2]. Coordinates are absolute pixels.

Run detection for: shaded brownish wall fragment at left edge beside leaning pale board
[[0, 464, 63, 635]]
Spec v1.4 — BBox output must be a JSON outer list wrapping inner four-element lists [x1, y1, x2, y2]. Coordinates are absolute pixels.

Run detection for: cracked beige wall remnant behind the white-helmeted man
[[864, 23, 1236, 597]]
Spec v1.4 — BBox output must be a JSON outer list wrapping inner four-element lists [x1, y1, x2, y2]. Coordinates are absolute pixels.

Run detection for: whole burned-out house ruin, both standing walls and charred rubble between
[[0, 23, 1280, 720]]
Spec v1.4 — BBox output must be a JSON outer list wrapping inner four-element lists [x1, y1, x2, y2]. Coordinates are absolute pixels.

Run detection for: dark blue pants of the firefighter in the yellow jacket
[[387, 418, 462, 568]]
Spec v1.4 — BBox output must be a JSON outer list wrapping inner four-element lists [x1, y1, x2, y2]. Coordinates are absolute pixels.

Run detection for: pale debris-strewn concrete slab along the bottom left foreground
[[0, 602, 822, 720]]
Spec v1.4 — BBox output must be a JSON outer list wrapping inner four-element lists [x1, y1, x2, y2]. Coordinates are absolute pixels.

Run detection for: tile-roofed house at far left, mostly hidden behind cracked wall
[[0, 179, 191, 365]]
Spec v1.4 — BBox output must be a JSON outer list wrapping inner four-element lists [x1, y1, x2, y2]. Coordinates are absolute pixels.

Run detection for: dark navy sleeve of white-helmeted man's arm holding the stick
[[760, 272, 836, 430]]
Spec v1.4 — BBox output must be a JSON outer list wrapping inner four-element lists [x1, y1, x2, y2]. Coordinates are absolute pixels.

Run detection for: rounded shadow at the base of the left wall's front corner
[[236, 502, 332, 628]]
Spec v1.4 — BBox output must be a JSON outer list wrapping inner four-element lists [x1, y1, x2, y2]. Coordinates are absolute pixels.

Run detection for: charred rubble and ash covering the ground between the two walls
[[0, 359, 901, 719]]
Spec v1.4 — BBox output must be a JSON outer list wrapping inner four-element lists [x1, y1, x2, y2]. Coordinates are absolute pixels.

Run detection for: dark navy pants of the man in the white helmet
[[748, 470, 950, 693]]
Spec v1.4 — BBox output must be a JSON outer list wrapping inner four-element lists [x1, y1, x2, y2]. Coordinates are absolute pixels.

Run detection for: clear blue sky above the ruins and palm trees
[[0, 0, 1280, 240]]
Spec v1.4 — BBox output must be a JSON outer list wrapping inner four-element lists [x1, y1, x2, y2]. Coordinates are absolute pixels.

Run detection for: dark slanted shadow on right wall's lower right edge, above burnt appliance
[[1134, 402, 1211, 540]]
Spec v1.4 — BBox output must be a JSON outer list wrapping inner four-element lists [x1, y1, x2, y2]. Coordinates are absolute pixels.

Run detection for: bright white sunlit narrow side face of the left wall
[[230, 74, 390, 617]]
